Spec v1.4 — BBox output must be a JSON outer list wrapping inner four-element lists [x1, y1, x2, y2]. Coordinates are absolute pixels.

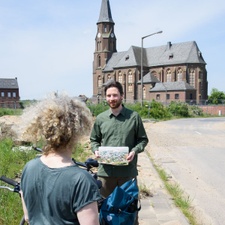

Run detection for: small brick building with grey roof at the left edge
[[0, 78, 20, 109]]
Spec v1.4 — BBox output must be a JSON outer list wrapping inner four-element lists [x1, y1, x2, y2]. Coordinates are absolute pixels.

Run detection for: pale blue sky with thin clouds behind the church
[[0, 0, 225, 100]]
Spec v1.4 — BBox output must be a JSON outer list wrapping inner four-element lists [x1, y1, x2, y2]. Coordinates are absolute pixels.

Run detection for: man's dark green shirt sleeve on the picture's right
[[131, 114, 148, 154]]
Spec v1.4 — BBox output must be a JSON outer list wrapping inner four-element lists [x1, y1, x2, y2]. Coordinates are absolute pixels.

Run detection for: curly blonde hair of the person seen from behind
[[17, 94, 92, 154]]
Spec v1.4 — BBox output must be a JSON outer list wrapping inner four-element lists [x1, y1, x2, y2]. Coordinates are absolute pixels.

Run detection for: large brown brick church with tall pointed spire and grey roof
[[93, 0, 208, 104]]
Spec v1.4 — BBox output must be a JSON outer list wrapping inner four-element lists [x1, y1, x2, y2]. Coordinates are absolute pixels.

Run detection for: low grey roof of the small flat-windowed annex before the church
[[150, 81, 196, 92]]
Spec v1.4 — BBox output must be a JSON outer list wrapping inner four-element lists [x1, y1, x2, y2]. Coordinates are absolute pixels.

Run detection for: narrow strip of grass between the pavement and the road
[[148, 151, 199, 225]]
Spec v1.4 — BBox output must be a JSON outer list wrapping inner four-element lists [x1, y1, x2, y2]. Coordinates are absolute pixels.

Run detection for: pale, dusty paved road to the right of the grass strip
[[149, 118, 225, 225]]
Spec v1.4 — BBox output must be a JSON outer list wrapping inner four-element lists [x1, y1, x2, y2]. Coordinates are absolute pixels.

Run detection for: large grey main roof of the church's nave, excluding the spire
[[104, 41, 206, 72]]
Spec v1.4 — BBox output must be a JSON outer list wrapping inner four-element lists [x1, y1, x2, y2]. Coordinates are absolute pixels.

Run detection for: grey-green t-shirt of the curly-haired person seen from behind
[[21, 158, 101, 225]]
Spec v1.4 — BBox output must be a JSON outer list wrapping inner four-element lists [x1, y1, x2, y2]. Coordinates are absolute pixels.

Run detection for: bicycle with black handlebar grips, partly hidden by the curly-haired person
[[0, 147, 102, 225]]
